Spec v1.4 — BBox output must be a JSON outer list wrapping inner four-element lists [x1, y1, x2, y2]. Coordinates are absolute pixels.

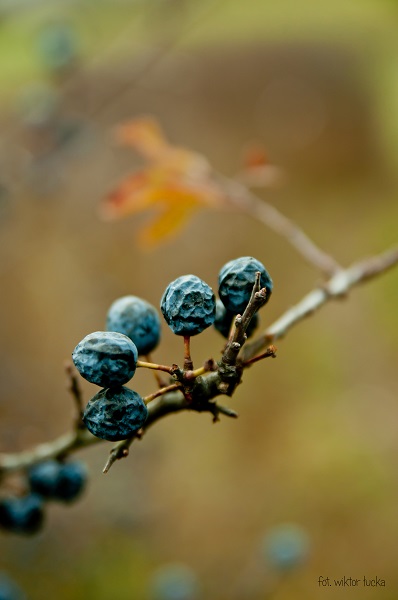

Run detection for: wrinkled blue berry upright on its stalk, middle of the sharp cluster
[[160, 275, 216, 336]]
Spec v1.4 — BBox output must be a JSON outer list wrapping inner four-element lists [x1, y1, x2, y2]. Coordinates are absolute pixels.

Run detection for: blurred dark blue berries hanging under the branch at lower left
[[0, 460, 87, 535]]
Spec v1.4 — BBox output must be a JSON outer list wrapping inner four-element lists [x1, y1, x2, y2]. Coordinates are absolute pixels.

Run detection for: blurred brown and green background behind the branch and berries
[[0, 0, 398, 600]]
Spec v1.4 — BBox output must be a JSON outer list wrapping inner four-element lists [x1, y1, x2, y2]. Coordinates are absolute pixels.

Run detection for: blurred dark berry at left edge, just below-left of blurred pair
[[0, 494, 44, 534]]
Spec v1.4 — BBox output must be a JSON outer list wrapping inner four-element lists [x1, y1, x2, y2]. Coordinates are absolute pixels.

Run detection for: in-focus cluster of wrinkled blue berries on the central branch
[[72, 256, 272, 441]]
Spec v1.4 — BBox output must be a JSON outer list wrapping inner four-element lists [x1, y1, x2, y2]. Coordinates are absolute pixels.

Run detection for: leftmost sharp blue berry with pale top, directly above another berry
[[72, 331, 138, 387]]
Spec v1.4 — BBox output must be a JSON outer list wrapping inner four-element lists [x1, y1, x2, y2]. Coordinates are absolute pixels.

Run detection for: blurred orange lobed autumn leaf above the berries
[[100, 117, 224, 246]]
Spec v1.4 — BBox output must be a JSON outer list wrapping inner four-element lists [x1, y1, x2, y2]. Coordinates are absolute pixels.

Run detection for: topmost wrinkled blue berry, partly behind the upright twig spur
[[218, 256, 273, 315]]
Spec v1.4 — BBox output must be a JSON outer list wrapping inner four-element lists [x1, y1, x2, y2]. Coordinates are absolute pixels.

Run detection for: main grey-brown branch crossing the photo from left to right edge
[[0, 247, 398, 475]]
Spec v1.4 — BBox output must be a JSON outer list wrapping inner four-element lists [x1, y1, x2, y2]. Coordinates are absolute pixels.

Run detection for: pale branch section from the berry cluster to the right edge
[[242, 247, 398, 361]]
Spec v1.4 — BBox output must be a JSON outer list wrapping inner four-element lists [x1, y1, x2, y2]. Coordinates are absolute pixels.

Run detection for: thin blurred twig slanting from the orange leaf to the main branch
[[214, 173, 342, 277]]
